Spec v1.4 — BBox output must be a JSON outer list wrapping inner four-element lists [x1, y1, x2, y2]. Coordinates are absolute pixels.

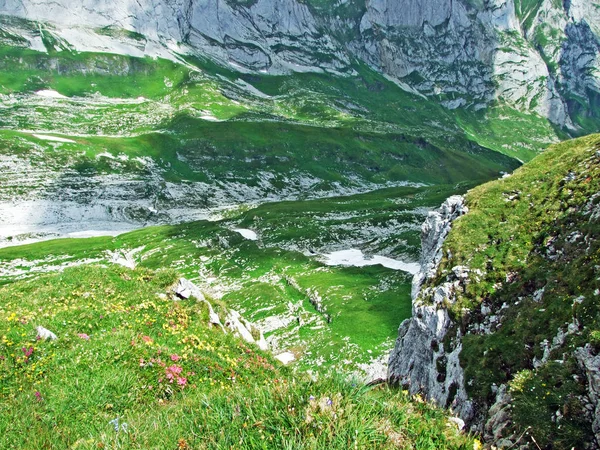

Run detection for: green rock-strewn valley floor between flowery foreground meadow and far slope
[[0, 185, 466, 378]]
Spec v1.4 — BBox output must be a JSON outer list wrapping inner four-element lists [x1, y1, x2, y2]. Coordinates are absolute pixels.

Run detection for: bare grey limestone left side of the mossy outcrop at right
[[388, 196, 473, 421]]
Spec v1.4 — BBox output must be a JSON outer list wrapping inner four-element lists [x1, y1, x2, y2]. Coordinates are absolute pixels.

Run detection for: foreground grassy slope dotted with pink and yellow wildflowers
[[0, 265, 474, 449]]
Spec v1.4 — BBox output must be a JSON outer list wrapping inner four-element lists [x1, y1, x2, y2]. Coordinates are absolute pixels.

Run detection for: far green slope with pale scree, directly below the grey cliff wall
[[0, 21, 528, 245]]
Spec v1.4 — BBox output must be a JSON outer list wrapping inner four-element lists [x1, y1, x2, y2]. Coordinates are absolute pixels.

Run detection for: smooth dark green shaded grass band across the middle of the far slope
[[95, 116, 517, 188]]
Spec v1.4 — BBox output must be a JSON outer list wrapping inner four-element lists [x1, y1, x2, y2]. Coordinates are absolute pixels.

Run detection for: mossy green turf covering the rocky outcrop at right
[[432, 135, 600, 448]]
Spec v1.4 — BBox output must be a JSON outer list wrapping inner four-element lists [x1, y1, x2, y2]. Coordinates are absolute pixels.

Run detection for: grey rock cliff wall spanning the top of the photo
[[0, 0, 600, 127]]
